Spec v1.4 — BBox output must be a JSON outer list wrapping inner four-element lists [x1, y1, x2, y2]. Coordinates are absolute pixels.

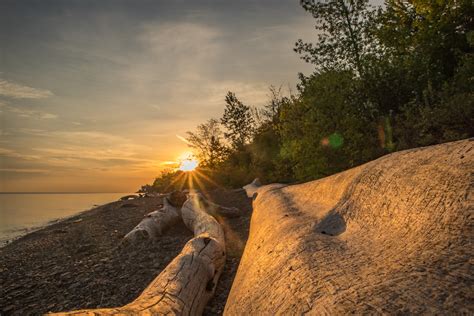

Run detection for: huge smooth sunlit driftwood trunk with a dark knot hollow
[[224, 140, 474, 315]]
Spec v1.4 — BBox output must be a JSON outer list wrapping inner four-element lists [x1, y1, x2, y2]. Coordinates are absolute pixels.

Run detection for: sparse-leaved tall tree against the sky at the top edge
[[294, 0, 377, 75]]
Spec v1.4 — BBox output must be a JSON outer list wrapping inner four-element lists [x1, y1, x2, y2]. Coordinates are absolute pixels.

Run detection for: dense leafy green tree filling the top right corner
[[376, 0, 474, 99]]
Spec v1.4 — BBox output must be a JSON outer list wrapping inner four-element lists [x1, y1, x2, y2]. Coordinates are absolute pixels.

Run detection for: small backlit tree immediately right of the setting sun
[[186, 119, 228, 168]]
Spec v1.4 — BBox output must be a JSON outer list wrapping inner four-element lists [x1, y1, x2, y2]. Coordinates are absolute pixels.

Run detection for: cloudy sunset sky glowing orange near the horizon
[[0, 0, 316, 192]]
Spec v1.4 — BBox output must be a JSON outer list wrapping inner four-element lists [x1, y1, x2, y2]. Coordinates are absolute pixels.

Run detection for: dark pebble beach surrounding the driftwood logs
[[0, 189, 251, 315]]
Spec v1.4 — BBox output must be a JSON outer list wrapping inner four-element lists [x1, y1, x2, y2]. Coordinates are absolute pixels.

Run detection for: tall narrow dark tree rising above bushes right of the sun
[[221, 91, 255, 150]]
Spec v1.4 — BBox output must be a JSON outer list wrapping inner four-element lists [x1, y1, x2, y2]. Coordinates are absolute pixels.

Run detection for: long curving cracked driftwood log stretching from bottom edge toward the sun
[[55, 196, 226, 315]]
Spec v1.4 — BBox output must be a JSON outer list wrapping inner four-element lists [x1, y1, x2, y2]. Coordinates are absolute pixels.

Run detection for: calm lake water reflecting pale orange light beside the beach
[[0, 193, 130, 246]]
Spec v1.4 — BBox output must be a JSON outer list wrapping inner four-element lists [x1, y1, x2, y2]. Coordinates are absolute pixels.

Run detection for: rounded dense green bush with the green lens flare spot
[[280, 71, 383, 181]]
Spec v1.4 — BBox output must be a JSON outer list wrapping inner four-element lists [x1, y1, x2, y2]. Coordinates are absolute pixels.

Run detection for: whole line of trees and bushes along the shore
[[150, 0, 474, 189]]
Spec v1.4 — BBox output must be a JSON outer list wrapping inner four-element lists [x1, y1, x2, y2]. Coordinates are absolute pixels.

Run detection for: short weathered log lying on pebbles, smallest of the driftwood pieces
[[121, 197, 179, 246]]
